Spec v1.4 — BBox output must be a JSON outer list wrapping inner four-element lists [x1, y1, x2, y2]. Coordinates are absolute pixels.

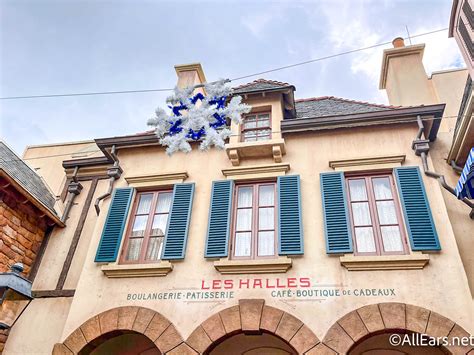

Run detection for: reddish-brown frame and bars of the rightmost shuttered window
[[344, 171, 410, 256]]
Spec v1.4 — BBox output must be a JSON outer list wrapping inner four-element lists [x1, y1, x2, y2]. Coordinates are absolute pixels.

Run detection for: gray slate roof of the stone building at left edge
[[0, 141, 56, 214]]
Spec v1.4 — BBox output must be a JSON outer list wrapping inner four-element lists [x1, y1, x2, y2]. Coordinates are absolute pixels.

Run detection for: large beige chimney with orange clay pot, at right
[[379, 37, 437, 106]]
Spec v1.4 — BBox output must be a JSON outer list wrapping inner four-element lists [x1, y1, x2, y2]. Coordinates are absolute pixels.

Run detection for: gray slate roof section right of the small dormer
[[295, 96, 397, 118]]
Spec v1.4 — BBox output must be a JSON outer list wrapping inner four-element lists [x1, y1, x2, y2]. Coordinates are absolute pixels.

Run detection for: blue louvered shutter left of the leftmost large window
[[95, 187, 134, 263]]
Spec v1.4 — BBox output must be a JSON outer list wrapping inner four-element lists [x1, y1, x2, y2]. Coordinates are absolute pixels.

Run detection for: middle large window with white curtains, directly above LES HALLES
[[232, 182, 276, 259]]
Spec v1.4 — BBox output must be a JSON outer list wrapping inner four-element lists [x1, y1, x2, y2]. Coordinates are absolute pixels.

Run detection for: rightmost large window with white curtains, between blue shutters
[[346, 174, 407, 255]]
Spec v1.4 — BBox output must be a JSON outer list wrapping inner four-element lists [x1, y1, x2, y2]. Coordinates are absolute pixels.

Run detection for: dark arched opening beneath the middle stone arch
[[206, 333, 297, 355]]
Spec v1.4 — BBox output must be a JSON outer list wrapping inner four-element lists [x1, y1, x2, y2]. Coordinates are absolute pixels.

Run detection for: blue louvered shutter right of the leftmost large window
[[162, 184, 194, 260]]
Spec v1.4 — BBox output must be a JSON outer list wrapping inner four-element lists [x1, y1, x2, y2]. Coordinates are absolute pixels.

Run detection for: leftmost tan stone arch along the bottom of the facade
[[53, 306, 186, 355]]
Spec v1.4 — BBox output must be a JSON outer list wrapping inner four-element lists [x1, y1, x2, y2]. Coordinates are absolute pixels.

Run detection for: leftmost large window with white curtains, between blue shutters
[[122, 191, 173, 263]]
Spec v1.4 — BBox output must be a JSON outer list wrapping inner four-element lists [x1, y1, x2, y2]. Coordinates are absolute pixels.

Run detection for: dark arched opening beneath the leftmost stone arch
[[79, 330, 161, 355]]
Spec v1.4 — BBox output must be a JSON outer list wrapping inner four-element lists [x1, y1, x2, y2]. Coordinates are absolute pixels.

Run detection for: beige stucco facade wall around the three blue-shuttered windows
[[6, 124, 473, 354]]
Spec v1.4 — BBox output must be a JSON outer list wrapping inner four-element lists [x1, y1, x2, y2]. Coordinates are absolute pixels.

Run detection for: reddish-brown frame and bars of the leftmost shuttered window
[[119, 188, 173, 264]]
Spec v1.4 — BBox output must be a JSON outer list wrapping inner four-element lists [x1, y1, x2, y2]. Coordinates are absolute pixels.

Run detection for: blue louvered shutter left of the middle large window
[[204, 180, 234, 258]]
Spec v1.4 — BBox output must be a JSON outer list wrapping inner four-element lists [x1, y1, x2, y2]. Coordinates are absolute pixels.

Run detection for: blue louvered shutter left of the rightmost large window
[[320, 172, 353, 254]]
